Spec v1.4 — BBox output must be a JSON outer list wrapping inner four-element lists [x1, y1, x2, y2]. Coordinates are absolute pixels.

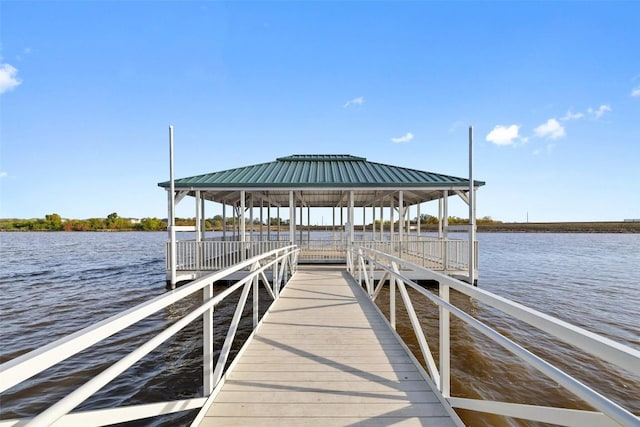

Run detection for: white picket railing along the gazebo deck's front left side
[[165, 240, 289, 271]]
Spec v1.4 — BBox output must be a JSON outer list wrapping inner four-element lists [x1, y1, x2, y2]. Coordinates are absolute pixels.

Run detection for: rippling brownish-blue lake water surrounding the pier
[[0, 233, 640, 425]]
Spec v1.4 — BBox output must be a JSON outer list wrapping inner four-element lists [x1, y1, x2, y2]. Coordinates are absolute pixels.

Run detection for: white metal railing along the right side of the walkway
[[347, 246, 640, 427]]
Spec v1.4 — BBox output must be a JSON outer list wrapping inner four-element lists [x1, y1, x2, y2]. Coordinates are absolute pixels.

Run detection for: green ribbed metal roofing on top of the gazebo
[[158, 154, 485, 189]]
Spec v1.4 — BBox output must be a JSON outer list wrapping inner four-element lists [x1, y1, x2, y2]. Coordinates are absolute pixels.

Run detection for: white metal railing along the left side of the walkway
[[0, 246, 299, 427]]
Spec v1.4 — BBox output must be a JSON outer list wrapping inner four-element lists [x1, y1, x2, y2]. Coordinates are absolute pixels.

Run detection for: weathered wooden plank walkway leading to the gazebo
[[195, 266, 463, 426]]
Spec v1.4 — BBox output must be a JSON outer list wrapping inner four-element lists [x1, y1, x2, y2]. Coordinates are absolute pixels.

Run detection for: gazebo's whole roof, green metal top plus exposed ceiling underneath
[[158, 154, 485, 207]]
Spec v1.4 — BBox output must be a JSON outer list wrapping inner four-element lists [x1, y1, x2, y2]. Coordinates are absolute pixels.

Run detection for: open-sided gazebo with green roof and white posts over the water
[[158, 154, 484, 284]]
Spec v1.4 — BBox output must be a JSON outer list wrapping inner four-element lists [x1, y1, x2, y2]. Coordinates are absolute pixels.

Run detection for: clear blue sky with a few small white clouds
[[0, 1, 640, 221]]
